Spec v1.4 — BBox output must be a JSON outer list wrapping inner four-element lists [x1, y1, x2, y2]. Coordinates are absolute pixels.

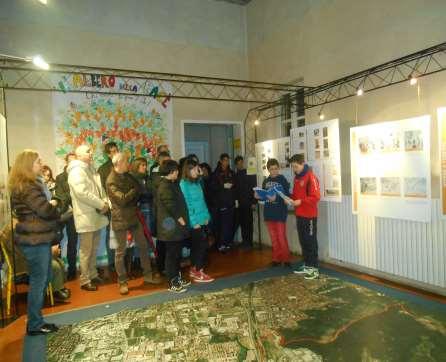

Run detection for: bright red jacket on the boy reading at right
[[292, 165, 321, 219]]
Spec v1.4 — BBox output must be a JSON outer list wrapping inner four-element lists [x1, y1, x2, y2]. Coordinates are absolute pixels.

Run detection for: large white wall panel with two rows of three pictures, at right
[[350, 116, 431, 222]]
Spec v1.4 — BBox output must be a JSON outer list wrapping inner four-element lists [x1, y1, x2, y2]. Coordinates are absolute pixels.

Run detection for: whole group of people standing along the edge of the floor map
[[9, 142, 320, 335]]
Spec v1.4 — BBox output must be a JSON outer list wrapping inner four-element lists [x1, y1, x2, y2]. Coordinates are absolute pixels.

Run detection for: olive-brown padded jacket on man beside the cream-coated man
[[106, 170, 141, 231]]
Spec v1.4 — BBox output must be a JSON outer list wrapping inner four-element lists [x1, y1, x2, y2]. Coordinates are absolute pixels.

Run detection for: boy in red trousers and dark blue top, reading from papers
[[255, 158, 291, 267]]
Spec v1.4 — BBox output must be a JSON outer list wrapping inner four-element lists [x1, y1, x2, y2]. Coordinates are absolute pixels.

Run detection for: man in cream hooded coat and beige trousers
[[67, 145, 110, 291]]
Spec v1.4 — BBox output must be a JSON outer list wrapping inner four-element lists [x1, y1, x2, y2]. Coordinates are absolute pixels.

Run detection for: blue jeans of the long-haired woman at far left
[[19, 243, 51, 331]]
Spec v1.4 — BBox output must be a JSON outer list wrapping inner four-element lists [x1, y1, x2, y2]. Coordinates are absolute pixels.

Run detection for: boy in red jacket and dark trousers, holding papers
[[290, 154, 321, 279]]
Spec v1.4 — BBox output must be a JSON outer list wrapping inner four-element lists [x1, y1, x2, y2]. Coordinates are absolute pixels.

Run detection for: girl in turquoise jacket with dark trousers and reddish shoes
[[180, 159, 214, 283]]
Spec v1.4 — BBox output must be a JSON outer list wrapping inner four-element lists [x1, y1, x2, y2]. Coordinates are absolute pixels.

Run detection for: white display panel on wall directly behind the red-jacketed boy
[[291, 119, 342, 202]]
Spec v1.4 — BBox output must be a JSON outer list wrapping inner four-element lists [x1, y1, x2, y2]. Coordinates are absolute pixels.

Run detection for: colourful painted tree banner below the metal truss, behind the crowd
[[53, 93, 173, 169]]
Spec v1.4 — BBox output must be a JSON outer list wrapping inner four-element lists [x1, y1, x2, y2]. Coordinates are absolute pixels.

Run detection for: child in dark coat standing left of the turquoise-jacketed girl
[[155, 160, 190, 293]]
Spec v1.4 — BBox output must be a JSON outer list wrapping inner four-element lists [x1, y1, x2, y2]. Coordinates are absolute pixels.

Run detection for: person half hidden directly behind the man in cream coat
[[55, 152, 78, 280]]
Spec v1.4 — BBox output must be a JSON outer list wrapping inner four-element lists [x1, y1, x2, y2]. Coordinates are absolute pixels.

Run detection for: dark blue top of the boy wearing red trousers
[[262, 175, 290, 222]]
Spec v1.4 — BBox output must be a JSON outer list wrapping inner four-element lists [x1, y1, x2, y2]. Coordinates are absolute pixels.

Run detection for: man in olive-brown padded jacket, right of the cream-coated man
[[106, 153, 160, 295]]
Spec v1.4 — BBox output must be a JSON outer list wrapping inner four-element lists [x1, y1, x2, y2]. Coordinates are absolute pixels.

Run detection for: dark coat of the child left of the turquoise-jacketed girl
[[155, 177, 188, 241]]
